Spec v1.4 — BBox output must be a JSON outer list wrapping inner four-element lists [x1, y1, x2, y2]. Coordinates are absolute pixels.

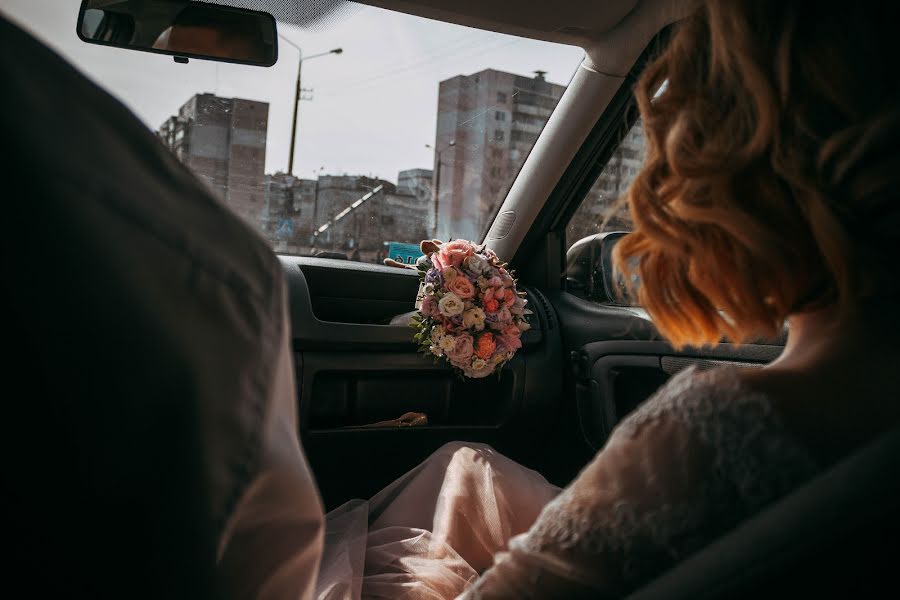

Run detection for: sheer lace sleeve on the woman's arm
[[463, 369, 816, 600]]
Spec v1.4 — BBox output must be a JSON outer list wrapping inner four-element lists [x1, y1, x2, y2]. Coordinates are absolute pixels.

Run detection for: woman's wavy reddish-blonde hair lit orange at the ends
[[615, 0, 900, 347]]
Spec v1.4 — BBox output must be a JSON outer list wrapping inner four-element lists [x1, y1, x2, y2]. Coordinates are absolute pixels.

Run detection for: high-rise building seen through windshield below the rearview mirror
[[158, 94, 269, 227]]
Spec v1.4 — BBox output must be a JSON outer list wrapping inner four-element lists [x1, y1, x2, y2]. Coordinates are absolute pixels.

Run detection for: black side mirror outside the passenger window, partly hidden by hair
[[566, 231, 638, 306]]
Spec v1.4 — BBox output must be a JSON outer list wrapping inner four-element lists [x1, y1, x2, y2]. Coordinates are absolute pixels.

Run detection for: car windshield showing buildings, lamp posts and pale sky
[[2, 0, 583, 262]]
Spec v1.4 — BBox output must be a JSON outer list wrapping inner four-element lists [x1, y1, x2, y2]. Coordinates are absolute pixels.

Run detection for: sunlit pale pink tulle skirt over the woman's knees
[[317, 442, 560, 600]]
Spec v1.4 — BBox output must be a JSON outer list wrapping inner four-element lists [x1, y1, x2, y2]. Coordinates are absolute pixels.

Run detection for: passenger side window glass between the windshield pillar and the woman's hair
[[566, 120, 646, 249]]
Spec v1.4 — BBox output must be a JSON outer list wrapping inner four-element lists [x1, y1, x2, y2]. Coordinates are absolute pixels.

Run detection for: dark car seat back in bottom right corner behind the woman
[[629, 430, 900, 600]]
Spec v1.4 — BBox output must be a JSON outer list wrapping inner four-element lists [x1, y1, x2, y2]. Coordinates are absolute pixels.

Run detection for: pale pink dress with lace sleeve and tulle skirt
[[318, 367, 819, 600]]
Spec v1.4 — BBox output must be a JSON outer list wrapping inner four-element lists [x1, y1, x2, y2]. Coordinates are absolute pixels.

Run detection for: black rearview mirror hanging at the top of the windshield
[[78, 0, 278, 67]]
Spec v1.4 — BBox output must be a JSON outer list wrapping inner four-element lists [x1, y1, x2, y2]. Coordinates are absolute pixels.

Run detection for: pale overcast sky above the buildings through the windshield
[[0, 0, 583, 181]]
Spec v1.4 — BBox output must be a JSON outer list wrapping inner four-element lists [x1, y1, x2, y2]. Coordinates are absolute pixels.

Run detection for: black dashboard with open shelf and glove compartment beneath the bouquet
[[282, 257, 563, 509]]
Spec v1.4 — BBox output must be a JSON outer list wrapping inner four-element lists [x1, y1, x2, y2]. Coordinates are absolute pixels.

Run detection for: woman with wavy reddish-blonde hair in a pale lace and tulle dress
[[317, 0, 900, 600]]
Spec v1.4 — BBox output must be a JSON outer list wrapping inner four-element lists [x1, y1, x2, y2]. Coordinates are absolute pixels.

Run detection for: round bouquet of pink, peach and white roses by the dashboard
[[412, 240, 531, 379]]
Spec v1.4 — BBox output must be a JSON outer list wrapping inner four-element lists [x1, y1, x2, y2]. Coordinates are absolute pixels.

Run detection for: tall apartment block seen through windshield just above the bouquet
[[432, 69, 566, 241]]
